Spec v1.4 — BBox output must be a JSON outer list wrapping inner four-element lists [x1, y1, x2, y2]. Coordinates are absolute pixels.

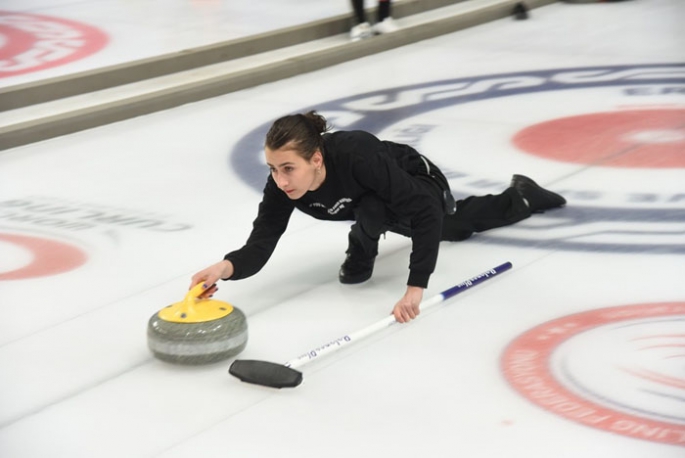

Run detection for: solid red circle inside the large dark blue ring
[[512, 109, 685, 168]]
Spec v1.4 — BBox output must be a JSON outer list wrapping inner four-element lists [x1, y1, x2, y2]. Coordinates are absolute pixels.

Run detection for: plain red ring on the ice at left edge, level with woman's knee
[[0, 234, 88, 281]]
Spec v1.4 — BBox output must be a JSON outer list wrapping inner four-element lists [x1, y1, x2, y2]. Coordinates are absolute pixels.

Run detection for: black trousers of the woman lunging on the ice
[[348, 181, 531, 257]]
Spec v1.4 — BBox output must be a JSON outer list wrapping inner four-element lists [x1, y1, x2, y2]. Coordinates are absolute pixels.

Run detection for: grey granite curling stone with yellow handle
[[147, 283, 247, 365]]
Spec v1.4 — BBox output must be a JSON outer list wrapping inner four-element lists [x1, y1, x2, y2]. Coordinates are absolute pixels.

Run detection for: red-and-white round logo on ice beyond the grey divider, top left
[[0, 11, 108, 78]]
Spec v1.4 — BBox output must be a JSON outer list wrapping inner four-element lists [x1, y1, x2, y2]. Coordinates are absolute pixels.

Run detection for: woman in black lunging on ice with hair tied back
[[191, 111, 566, 323]]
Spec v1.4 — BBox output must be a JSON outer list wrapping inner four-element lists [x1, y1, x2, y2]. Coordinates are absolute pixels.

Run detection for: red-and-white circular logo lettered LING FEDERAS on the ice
[[502, 302, 685, 446]]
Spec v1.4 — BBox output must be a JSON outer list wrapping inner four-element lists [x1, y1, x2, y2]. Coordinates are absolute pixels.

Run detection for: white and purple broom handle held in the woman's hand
[[284, 262, 511, 369]]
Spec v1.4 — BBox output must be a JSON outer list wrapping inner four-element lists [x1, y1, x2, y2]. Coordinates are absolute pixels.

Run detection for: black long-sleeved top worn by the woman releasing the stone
[[224, 131, 444, 288]]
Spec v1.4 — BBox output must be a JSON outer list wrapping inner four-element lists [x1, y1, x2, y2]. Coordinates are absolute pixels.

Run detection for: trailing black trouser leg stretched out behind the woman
[[442, 188, 531, 241]]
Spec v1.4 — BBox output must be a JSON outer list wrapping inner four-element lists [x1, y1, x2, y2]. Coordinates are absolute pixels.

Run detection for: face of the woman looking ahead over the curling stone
[[264, 145, 323, 200]]
